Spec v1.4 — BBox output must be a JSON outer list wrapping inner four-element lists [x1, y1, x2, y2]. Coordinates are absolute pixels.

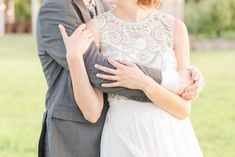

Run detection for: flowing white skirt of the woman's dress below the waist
[[101, 99, 203, 157]]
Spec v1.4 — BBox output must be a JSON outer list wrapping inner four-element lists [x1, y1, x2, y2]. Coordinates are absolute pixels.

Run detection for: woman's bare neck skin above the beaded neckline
[[113, 0, 153, 22]]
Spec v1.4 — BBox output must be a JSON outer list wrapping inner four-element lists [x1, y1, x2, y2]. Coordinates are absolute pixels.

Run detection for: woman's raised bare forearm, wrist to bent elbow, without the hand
[[68, 57, 103, 123]]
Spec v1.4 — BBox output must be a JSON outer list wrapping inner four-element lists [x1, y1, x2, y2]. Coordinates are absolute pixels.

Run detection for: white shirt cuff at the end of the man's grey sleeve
[[161, 70, 179, 93]]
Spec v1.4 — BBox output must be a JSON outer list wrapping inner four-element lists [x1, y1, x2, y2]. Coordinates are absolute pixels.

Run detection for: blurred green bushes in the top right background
[[185, 0, 235, 39]]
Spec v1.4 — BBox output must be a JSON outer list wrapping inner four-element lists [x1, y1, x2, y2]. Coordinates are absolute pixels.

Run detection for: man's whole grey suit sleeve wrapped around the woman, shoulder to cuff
[[38, 1, 165, 101]]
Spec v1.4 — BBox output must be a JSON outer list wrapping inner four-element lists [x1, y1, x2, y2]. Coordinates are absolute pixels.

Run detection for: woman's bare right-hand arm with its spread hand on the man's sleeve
[[97, 20, 204, 119]]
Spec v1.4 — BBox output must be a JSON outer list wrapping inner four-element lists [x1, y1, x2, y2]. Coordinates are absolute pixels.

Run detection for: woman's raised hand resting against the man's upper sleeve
[[59, 24, 94, 60]]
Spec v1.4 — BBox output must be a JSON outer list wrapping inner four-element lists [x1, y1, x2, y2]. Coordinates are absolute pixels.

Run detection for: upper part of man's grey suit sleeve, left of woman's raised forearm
[[38, 2, 79, 70]]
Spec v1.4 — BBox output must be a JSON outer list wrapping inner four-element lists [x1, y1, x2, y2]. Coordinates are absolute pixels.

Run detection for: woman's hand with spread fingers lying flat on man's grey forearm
[[95, 58, 147, 90]]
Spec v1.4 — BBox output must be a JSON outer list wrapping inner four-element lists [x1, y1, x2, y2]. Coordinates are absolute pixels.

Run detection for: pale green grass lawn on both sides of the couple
[[0, 36, 235, 157]]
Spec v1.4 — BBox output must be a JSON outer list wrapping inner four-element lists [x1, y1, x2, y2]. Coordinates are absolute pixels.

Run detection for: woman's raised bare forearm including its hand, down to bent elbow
[[60, 25, 103, 123]]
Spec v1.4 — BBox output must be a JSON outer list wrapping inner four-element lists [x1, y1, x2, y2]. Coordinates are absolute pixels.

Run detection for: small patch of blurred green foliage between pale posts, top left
[[15, 0, 31, 22]]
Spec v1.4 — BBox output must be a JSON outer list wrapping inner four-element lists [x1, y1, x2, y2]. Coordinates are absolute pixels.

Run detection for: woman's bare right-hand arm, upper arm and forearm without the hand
[[140, 19, 191, 119]]
